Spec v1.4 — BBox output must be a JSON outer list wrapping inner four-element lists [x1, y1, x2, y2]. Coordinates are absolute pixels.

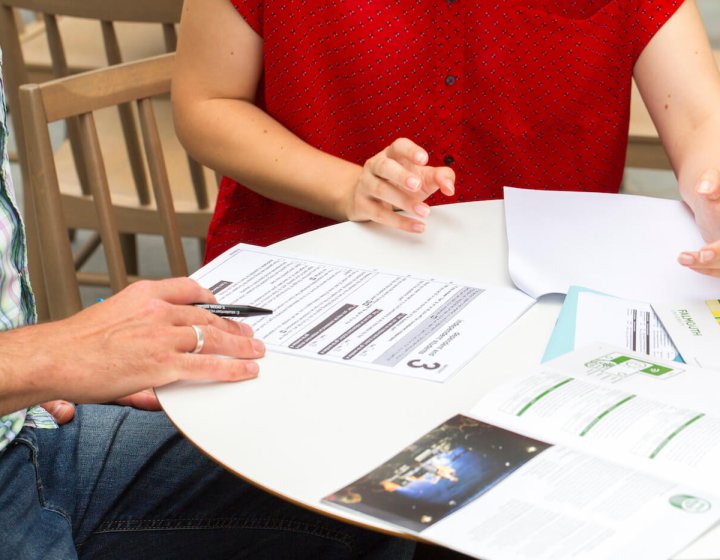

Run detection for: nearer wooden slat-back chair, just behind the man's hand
[[20, 54, 212, 319]]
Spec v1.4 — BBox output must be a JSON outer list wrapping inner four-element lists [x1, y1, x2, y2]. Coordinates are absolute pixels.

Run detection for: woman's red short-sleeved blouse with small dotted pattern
[[206, 0, 682, 259]]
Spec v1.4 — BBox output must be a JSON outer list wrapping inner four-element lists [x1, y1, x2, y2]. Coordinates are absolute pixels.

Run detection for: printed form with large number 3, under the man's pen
[[192, 244, 535, 382]]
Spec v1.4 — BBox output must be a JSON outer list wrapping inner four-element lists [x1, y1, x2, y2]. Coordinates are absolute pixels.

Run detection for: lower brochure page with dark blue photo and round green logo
[[325, 415, 720, 560]]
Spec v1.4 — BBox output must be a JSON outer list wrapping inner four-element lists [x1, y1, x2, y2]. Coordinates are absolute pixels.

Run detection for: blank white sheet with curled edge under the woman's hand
[[505, 187, 720, 302]]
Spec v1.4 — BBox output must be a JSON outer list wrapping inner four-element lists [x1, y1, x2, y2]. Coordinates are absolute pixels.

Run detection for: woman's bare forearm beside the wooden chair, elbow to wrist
[[173, 92, 362, 220]]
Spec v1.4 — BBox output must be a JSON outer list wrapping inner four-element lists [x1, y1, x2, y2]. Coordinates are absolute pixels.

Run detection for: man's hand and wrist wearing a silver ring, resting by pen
[[0, 278, 265, 417]]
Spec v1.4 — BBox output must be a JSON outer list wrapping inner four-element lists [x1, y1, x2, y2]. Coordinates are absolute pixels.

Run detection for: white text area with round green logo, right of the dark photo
[[422, 446, 720, 560]]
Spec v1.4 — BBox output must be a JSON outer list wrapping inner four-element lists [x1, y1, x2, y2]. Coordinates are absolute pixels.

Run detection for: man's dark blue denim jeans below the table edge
[[0, 405, 414, 560]]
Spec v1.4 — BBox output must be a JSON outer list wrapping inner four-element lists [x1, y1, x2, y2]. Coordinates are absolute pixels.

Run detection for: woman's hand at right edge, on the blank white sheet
[[678, 169, 720, 277]]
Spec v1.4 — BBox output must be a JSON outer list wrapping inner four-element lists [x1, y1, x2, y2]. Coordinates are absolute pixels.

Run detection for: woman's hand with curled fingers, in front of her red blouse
[[347, 138, 455, 233]]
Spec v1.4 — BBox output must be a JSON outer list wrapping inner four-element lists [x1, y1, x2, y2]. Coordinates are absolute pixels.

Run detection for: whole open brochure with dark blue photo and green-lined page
[[325, 345, 720, 560]]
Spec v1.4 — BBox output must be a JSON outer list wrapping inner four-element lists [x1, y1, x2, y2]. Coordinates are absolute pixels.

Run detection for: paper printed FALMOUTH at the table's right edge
[[653, 300, 720, 370]]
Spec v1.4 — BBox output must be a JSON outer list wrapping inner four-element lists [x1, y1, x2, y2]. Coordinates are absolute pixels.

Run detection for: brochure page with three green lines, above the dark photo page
[[470, 345, 720, 494]]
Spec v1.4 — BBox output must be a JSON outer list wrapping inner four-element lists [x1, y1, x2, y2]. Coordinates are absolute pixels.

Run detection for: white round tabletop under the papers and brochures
[[158, 201, 720, 558]]
